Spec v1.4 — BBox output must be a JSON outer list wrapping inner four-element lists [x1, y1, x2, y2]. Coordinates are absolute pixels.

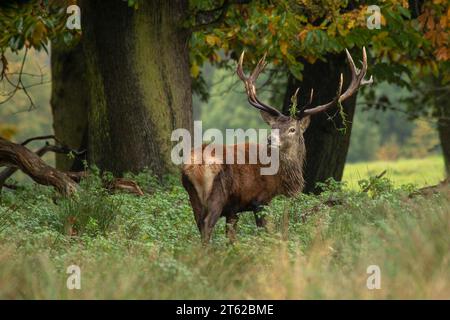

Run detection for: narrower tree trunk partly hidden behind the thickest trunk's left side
[[50, 43, 88, 171]]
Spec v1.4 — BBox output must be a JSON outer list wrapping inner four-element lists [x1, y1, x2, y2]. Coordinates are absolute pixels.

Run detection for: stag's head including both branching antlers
[[236, 47, 373, 158]]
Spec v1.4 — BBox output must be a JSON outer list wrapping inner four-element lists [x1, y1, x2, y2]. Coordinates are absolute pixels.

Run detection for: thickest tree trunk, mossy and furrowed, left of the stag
[[80, 0, 192, 175]]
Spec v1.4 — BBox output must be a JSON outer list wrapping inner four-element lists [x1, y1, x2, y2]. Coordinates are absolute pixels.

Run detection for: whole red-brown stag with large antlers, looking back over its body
[[181, 47, 373, 244]]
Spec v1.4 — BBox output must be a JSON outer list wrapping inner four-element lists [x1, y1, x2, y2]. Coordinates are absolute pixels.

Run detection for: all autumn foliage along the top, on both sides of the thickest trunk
[[0, 0, 450, 104]]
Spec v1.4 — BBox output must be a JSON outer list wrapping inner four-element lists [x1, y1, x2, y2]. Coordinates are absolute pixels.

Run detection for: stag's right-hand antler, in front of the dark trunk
[[297, 47, 373, 118]]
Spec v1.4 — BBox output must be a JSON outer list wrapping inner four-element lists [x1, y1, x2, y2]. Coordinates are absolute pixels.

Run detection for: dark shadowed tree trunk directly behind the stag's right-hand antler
[[283, 54, 356, 193]]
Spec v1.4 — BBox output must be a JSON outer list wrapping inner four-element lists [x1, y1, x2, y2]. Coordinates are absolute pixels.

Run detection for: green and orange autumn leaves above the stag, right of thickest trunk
[[191, 0, 450, 96]]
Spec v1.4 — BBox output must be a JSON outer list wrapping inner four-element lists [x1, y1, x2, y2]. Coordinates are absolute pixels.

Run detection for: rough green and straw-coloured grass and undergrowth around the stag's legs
[[0, 159, 450, 299]]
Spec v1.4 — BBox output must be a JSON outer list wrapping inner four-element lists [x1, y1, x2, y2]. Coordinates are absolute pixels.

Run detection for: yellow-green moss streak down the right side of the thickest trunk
[[133, 4, 190, 171]]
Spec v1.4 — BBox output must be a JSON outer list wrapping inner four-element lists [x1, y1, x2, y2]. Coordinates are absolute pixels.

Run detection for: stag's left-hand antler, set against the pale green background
[[236, 51, 284, 116]]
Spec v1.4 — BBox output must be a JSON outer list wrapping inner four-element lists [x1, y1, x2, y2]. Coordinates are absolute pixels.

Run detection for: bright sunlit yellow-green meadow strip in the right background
[[344, 155, 444, 189]]
